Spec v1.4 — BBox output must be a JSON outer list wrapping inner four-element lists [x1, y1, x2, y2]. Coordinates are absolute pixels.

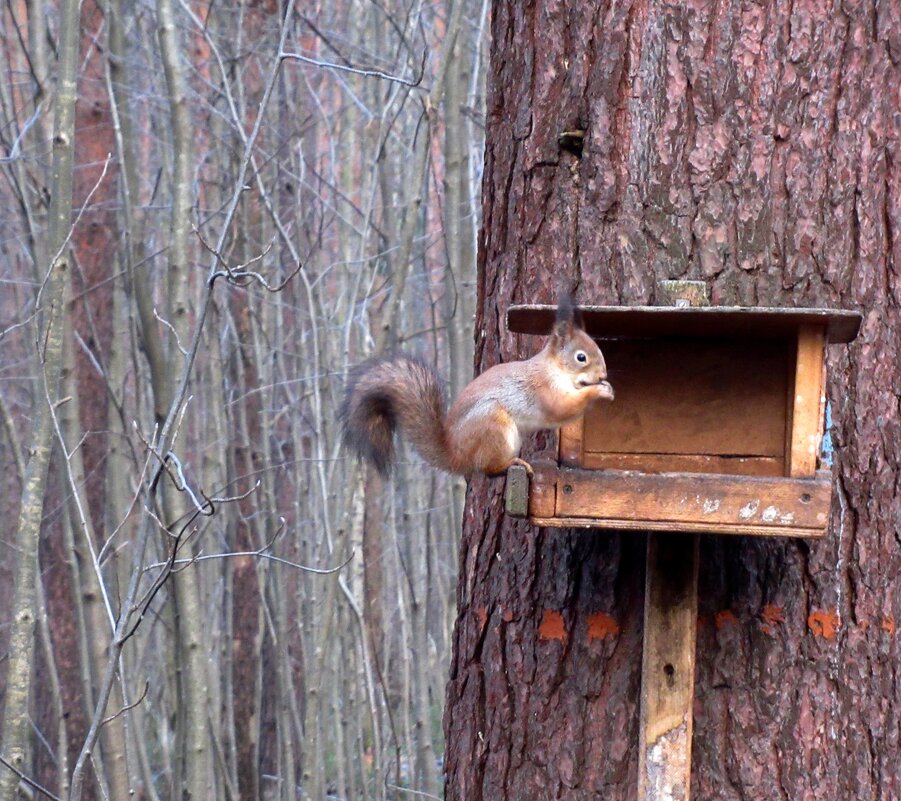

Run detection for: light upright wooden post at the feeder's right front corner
[[789, 325, 825, 477]]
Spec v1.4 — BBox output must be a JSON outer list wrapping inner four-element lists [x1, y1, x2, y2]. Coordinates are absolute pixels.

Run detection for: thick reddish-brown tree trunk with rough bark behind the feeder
[[445, 2, 901, 801]]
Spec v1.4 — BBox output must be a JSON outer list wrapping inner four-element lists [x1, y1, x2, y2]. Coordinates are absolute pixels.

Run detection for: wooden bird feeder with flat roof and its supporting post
[[507, 282, 861, 801]]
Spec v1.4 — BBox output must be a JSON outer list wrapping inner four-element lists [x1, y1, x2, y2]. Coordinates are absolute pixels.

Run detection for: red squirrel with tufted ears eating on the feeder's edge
[[340, 297, 613, 476]]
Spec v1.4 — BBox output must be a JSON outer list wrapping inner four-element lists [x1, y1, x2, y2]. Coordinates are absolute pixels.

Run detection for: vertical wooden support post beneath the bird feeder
[[638, 534, 698, 801]]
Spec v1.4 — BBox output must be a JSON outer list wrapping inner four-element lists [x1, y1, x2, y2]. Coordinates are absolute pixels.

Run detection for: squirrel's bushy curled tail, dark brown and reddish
[[339, 353, 450, 475]]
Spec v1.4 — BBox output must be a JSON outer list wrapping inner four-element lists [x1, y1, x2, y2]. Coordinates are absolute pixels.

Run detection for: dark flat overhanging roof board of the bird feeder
[[507, 305, 863, 342]]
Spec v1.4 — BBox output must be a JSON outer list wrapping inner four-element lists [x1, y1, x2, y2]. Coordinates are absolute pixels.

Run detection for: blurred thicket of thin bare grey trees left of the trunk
[[0, 0, 487, 799]]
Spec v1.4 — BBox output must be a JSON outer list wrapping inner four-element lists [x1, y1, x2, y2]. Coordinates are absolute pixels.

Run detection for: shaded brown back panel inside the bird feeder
[[583, 339, 794, 459]]
